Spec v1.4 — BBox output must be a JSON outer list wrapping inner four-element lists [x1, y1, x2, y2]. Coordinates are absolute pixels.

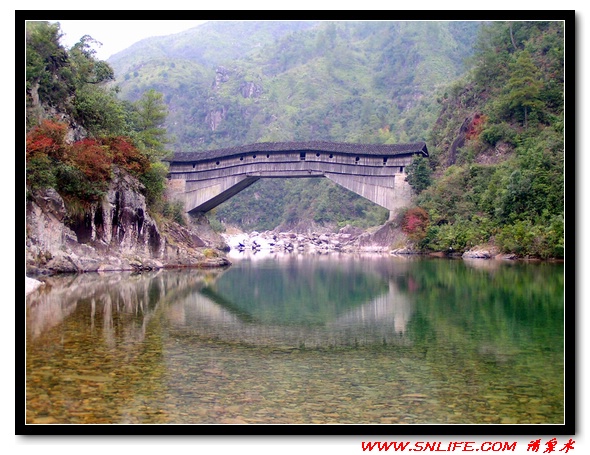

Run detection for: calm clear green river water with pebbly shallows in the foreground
[[26, 254, 564, 424]]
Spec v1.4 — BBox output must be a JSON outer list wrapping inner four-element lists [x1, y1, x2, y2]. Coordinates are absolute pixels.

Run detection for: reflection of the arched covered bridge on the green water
[[166, 255, 412, 348]]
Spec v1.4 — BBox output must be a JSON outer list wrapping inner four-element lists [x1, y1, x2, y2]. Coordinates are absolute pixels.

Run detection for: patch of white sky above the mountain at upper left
[[52, 20, 205, 60]]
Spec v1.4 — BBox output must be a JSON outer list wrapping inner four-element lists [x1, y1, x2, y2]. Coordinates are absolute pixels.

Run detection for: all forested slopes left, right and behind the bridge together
[[27, 21, 565, 257]]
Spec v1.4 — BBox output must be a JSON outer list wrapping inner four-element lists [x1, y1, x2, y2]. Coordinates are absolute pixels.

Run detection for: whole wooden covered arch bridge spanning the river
[[168, 141, 428, 219]]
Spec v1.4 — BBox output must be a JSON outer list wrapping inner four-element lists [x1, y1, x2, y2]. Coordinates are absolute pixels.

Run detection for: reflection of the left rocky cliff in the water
[[26, 271, 228, 347]]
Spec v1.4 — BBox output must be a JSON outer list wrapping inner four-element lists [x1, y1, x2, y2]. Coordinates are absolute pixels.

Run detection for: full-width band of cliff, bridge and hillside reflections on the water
[[27, 254, 563, 358]]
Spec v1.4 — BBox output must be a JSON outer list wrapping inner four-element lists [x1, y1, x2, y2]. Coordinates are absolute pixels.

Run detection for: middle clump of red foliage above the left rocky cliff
[[68, 139, 113, 182]]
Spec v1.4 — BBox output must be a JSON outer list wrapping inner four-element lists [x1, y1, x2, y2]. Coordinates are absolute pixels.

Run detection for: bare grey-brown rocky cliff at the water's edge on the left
[[26, 169, 229, 276]]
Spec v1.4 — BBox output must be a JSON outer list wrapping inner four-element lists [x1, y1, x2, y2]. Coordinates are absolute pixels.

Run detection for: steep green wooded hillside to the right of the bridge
[[414, 22, 565, 257]]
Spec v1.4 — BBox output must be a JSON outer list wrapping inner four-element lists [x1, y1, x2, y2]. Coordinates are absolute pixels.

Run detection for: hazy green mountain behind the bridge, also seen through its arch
[[109, 21, 480, 229]]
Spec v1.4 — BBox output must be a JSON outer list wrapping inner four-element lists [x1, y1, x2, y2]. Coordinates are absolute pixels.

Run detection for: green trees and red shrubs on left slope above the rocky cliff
[[26, 22, 178, 219]]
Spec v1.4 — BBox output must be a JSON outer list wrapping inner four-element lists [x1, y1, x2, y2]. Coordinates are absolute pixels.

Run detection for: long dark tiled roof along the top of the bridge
[[168, 141, 428, 166]]
